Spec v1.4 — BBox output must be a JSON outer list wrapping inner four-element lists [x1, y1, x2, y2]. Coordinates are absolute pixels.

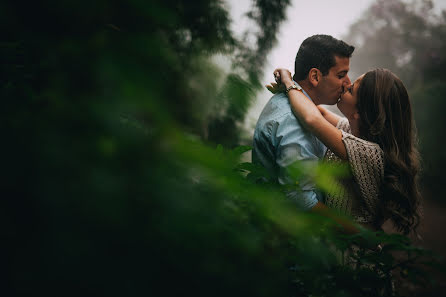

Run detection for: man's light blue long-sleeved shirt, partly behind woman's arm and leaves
[[252, 83, 327, 210]]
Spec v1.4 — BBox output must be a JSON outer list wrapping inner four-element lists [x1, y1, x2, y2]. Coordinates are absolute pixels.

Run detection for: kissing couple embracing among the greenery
[[252, 35, 420, 234]]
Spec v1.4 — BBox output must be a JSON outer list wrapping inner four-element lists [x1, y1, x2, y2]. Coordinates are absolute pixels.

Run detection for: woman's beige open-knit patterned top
[[325, 118, 384, 226]]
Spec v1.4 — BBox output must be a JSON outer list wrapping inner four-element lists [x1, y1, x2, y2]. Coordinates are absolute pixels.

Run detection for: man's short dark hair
[[293, 35, 355, 81]]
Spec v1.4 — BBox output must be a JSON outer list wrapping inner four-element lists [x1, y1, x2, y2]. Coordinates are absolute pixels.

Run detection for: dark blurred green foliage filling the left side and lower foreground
[[0, 0, 442, 296]]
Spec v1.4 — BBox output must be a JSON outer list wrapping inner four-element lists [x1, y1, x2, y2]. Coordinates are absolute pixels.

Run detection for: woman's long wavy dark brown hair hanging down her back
[[358, 69, 421, 234]]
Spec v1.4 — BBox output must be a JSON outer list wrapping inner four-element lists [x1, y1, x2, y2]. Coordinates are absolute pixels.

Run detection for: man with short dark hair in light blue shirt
[[252, 35, 354, 210]]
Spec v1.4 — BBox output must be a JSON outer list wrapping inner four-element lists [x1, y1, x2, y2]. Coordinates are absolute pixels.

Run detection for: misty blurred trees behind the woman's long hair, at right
[[345, 0, 446, 203]]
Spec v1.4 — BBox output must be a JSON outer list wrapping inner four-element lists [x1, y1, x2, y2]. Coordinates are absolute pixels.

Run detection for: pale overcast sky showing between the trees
[[226, 0, 446, 130]]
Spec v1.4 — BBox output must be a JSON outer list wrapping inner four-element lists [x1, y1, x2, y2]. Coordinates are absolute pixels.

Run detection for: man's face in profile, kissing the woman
[[317, 56, 351, 105]]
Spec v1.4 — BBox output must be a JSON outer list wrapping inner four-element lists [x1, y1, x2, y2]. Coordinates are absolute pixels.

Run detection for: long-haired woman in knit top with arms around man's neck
[[274, 69, 420, 234]]
